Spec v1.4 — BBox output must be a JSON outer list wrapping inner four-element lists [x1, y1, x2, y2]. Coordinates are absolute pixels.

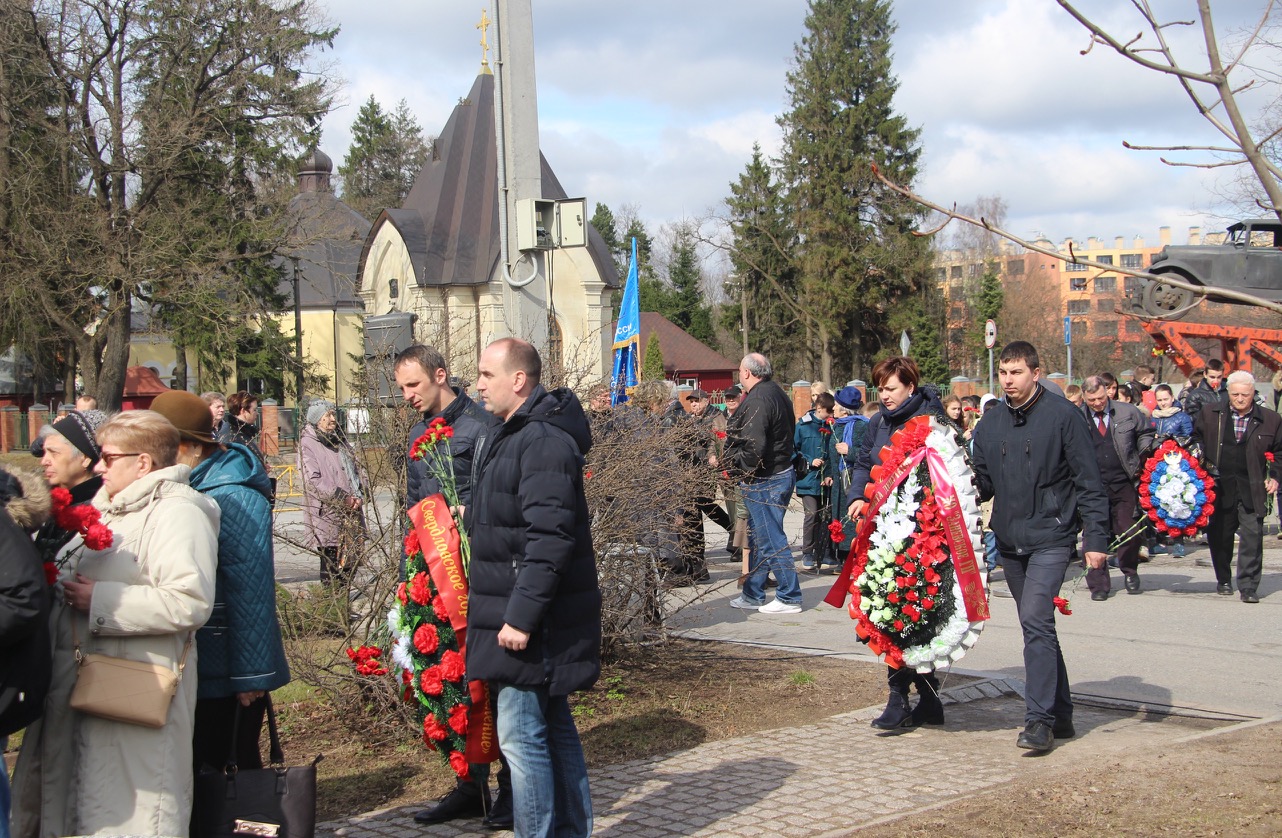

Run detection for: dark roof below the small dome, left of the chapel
[[279, 191, 369, 309]]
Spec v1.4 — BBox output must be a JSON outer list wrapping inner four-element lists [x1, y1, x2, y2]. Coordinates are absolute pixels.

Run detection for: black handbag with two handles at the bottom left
[[191, 693, 322, 838]]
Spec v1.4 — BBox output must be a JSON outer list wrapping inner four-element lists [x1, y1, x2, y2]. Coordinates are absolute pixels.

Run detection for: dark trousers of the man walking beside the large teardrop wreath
[[1001, 547, 1073, 727]]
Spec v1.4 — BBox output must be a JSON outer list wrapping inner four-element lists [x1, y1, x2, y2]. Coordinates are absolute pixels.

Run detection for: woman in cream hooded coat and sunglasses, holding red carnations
[[12, 410, 218, 838]]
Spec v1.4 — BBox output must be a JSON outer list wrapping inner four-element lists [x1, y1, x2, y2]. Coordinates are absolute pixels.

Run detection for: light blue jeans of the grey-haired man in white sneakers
[[738, 468, 801, 605]]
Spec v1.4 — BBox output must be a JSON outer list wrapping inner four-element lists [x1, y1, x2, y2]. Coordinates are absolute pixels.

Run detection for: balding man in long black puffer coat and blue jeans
[[467, 338, 601, 835]]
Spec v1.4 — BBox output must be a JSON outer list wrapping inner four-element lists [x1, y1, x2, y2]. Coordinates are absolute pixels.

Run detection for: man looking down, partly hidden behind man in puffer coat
[[394, 343, 512, 829]]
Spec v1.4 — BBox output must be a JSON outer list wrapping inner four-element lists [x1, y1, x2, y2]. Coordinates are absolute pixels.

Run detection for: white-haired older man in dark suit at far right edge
[[1194, 370, 1282, 604]]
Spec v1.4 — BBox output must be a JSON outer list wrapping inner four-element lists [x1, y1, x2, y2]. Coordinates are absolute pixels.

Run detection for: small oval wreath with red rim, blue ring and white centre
[[1140, 440, 1215, 537]]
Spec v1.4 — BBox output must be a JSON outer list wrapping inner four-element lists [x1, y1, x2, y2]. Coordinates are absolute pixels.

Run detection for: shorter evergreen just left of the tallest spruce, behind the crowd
[[720, 145, 794, 377]]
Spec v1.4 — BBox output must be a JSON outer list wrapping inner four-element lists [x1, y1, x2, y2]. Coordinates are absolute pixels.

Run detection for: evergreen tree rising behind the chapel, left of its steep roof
[[338, 96, 427, 218]]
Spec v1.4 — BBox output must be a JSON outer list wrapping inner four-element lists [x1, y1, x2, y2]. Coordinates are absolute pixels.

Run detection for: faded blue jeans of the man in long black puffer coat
[[492, 684, 592, 838]]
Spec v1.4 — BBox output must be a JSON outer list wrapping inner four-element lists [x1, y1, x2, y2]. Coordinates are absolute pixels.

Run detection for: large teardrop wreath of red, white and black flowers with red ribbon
[[828, 416, 988, 673]]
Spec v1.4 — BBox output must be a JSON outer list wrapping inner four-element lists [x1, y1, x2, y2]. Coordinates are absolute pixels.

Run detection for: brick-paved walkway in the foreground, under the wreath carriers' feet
[[317, 679, 1227, 838]]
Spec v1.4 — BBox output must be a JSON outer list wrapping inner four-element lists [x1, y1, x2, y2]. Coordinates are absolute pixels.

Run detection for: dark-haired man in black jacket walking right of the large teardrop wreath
[[974, 341, 1109, 751]]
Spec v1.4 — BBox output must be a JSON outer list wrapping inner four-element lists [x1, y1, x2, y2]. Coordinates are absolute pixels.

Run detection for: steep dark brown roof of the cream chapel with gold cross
[[358, 73, 619, 287]]
